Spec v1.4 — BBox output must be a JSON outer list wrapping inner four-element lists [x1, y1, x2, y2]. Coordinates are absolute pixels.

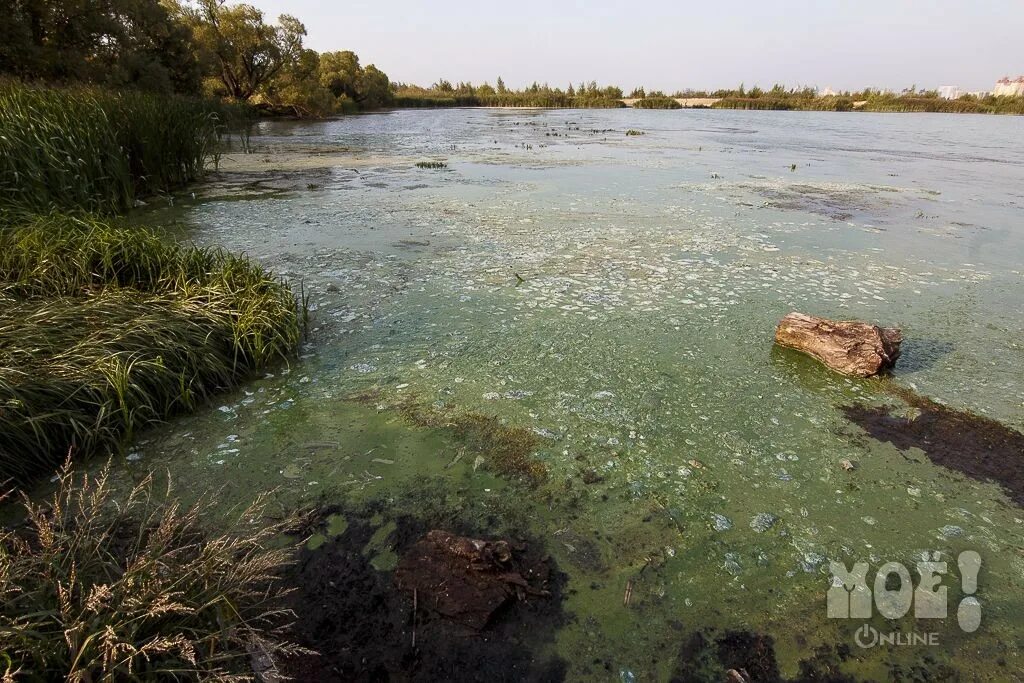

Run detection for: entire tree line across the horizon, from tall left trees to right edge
[[0, 0, 1024, 117]]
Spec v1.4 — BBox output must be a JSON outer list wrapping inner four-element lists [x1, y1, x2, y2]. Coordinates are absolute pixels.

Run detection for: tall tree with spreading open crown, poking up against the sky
[[184, 0, 306, 101]]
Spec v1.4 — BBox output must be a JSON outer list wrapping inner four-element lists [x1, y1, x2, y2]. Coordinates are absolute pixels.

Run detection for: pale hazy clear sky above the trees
[[243, 0, 1024, 92]]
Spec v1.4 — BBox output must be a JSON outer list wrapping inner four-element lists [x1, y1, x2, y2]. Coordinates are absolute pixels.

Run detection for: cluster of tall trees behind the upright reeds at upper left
[[0, 0, 392, 116]]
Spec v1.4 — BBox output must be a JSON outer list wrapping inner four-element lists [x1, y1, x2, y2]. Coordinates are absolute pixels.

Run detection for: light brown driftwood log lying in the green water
[[775, 312, 903, 377]]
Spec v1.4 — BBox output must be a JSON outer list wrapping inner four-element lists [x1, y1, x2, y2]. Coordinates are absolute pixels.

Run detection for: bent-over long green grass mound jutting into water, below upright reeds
[[0, 217, 305, 483]]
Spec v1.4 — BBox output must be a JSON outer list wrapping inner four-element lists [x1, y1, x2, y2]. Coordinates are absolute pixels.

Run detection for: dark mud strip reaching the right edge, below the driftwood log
[[841, 387, 1024, 506]]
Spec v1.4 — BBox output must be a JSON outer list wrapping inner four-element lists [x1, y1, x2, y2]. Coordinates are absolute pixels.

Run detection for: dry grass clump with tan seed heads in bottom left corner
[[0, 464, 302, 682]]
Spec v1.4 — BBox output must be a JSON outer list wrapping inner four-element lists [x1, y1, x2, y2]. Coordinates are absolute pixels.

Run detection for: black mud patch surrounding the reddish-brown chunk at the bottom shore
[[284, 493, 567, 683]]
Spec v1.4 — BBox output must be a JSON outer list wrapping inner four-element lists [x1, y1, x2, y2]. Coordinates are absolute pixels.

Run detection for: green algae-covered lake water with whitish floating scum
[[131, 110, 1024, 680]]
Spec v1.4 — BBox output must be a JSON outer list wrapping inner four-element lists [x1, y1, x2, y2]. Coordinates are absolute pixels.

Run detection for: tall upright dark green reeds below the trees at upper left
[[0, 81, 227, 214]]
